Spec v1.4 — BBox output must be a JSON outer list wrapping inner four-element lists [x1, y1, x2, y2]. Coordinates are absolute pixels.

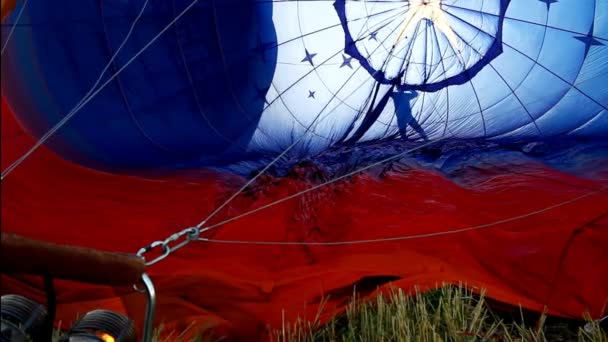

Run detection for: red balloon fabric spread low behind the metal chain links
[[2, 99, 608, 340]]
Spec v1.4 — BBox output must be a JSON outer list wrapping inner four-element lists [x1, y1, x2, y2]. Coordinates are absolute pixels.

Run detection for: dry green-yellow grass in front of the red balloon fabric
[[54, 286, 608, 342]]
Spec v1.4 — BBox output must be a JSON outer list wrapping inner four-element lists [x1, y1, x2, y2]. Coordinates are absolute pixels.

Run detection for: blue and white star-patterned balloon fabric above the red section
[[2, 0, 608, 170]]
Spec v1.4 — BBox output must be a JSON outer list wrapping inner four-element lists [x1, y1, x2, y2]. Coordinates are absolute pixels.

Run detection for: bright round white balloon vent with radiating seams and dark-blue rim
[[334, 0, 510, 92]]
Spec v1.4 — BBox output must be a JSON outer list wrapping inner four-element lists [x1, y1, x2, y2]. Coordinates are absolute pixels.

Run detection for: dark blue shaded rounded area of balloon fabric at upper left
[[2, 0, 277, 169]]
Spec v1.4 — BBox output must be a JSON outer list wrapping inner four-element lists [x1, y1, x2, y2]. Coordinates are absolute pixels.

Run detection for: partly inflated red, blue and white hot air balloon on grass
[[2, 0, 608, 337]]
